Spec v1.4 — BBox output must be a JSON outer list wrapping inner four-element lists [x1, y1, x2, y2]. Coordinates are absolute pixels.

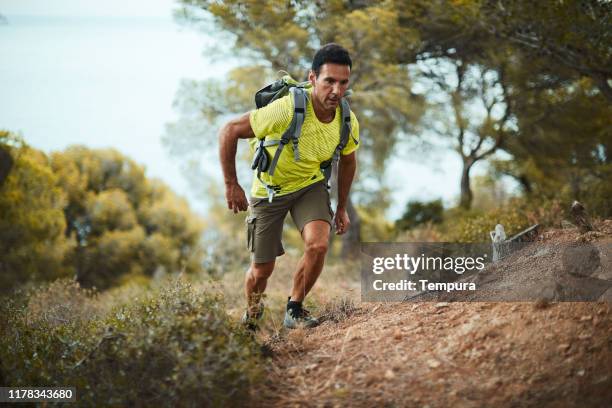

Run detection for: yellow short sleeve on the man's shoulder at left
[[249, 95, 293, 139]]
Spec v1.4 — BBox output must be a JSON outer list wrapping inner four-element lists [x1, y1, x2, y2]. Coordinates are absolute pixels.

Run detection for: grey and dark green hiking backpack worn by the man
[[251, 75, 359, 202]]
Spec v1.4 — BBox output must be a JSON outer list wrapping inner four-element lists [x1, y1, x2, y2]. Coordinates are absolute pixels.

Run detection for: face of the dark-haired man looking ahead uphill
[[308, 63, 351, 110]]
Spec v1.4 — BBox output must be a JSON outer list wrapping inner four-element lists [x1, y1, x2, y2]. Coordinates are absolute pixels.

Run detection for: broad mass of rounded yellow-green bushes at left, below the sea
[[0, 131, 203, 291]]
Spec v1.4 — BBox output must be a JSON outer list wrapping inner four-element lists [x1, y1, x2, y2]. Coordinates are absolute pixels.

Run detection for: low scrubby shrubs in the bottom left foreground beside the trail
[[0, 280, 259, 406]]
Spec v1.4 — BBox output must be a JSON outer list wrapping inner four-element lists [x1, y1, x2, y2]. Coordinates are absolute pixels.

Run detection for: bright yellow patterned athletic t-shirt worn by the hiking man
[[249, 89, 359, 198]]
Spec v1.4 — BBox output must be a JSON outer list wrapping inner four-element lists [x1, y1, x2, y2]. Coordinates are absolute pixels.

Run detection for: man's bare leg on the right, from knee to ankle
[[291, 220, 331, 302]]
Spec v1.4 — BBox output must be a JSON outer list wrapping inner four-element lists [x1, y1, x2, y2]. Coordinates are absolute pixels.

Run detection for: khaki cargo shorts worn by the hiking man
[[246, 181, 334, 263]]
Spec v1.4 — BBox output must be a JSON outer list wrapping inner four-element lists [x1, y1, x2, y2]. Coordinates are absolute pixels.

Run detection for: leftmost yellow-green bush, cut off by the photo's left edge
[[0, 131, 71, 291]]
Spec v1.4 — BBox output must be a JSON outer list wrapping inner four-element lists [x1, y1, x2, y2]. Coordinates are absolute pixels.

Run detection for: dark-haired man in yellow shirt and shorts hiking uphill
[[219, 44, 359, 330]]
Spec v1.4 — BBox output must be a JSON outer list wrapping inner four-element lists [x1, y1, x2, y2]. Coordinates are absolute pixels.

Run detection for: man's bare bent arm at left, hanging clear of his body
[[219, 112, 255, 213]]
